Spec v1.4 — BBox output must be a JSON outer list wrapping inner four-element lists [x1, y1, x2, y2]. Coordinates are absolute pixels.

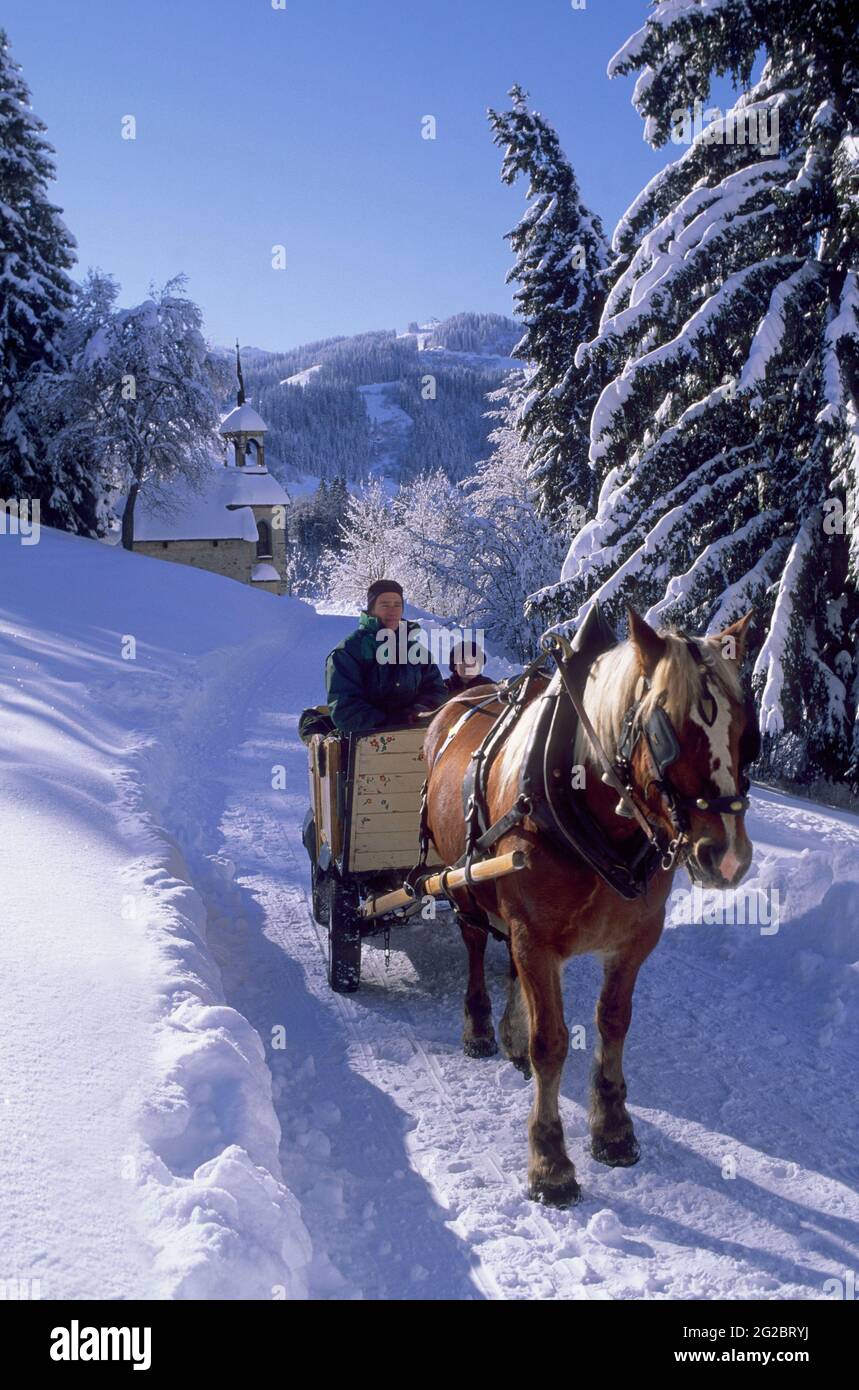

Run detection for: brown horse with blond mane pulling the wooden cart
[[424, 610, 759, 1207]]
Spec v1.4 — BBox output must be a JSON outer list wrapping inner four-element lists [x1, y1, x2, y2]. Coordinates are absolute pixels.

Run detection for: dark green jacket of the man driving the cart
[[325, 613, 449, 734]]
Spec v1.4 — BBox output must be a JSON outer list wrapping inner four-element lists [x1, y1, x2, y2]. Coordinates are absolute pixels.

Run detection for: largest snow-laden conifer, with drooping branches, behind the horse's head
[[535, 0, 859, 785]]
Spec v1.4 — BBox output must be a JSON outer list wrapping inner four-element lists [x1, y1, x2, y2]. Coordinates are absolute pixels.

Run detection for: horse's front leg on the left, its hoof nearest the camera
[[510, 926, 581, 1207]]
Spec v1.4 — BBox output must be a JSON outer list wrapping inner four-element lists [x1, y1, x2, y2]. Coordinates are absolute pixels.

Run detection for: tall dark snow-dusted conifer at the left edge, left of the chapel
[[0, 29, 76, 517]]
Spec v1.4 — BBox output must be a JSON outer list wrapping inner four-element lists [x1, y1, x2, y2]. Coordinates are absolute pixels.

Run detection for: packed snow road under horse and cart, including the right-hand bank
[[173, 633, 859, 1298]]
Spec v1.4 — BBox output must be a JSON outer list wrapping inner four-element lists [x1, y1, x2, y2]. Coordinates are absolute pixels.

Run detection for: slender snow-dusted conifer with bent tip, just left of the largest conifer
[[489, 86, 607, 520]]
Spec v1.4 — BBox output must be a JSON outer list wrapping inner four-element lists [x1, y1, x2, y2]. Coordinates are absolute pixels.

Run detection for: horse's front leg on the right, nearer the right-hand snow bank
[[589, 929, 660, 1168]]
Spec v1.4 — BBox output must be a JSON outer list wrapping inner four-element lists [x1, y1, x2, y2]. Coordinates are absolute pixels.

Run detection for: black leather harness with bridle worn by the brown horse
[[413, 605, 753, 911]]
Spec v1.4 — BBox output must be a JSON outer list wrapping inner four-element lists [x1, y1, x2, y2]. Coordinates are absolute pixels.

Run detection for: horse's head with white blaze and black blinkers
[[617, 610, 760, 888]]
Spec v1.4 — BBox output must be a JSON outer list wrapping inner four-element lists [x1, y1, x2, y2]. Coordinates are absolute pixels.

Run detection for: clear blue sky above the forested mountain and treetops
[[6, 0, 678, 349]]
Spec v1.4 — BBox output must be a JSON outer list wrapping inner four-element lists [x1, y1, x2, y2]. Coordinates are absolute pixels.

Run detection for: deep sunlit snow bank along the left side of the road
[[0, 528, 314, 1298]]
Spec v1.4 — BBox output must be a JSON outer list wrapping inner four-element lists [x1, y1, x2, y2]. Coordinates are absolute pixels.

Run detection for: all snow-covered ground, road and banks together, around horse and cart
[[0, 531, 859, 1298]]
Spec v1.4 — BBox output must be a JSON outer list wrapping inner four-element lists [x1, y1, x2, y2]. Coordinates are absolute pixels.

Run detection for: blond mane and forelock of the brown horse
[[575, 630, 742, 767]]
